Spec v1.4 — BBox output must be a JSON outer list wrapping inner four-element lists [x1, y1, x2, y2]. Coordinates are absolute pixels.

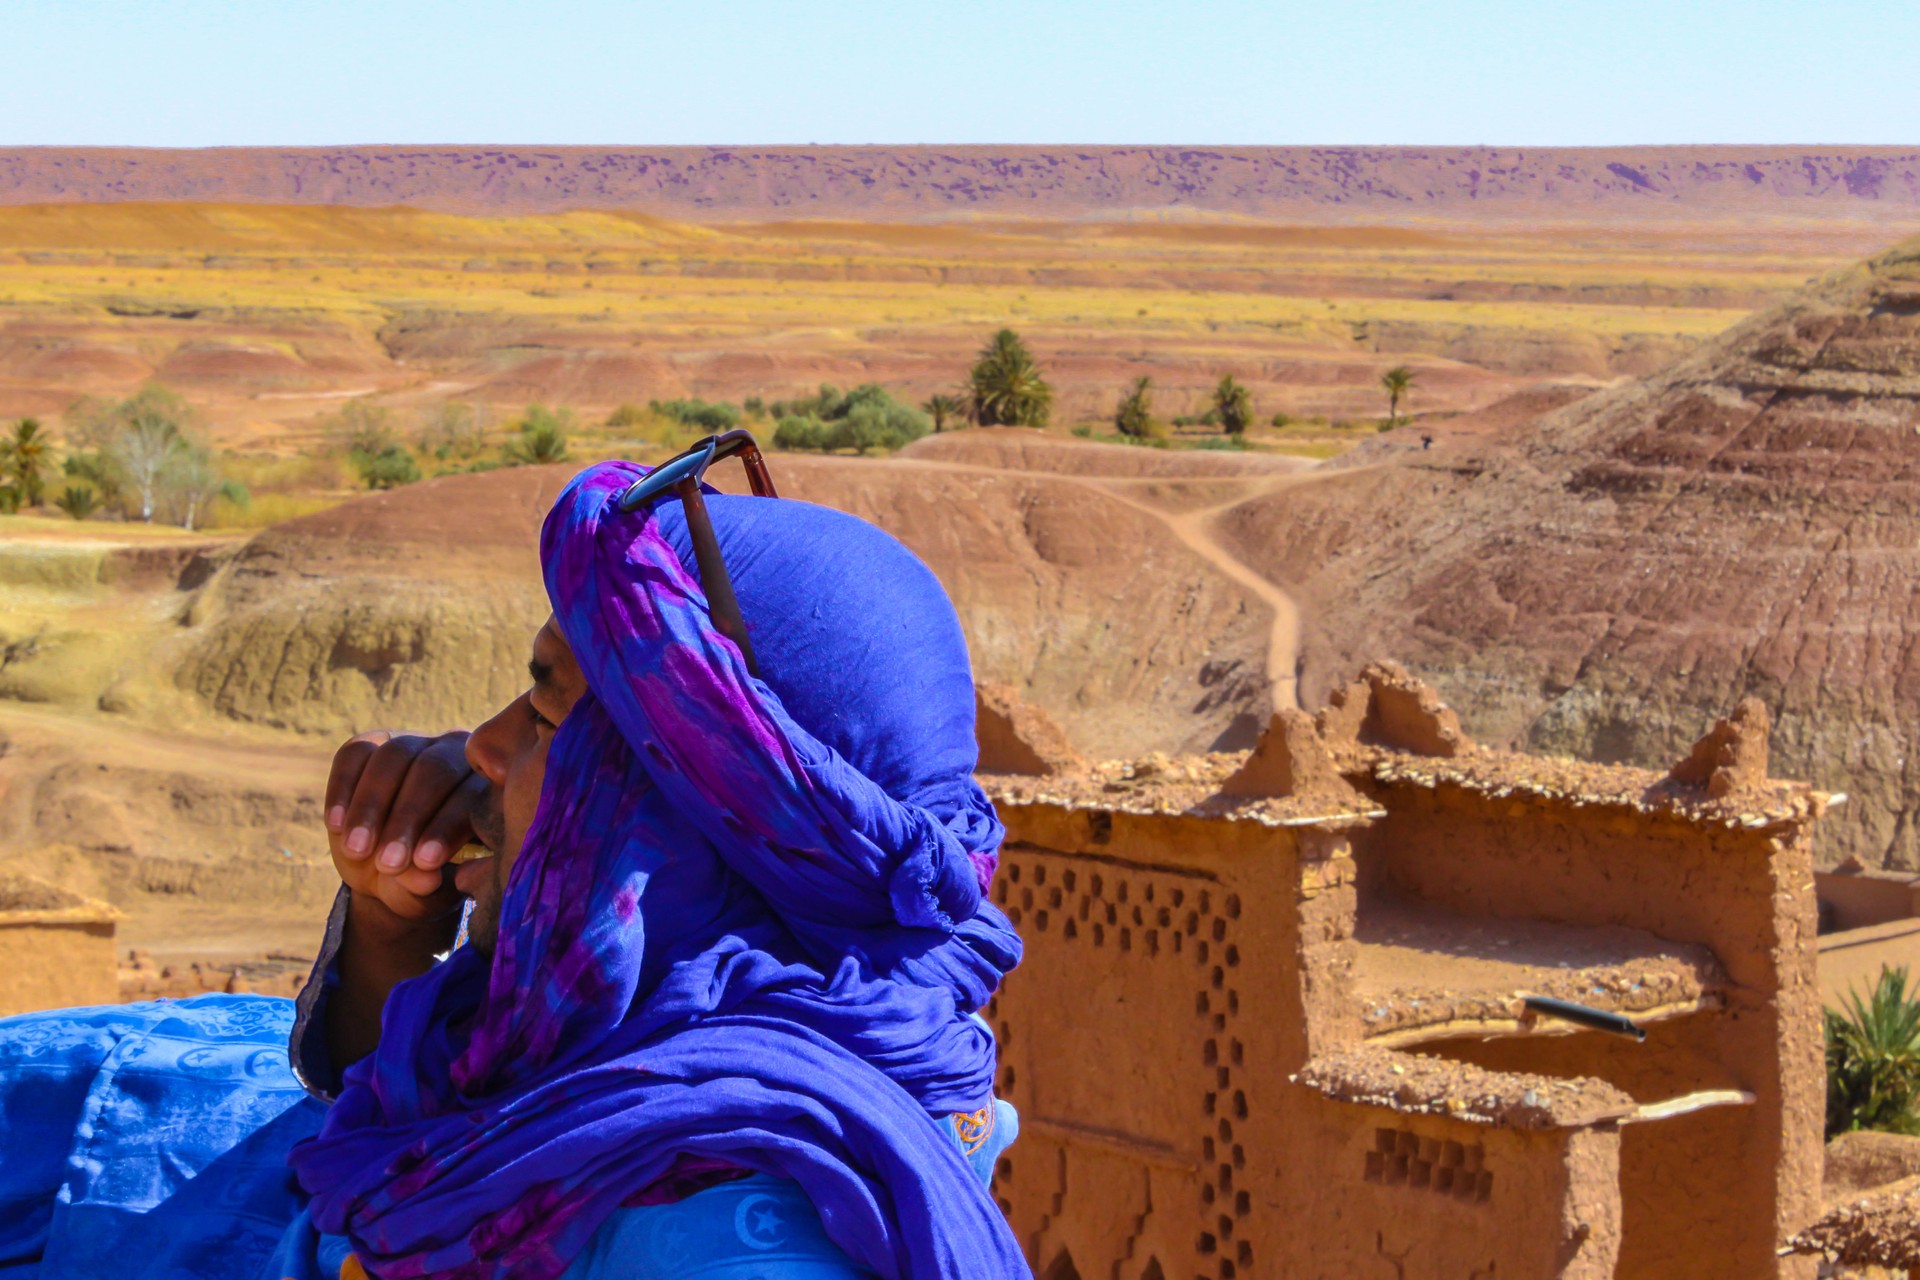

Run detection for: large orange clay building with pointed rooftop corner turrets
[[989, 666, 1828, 1280]]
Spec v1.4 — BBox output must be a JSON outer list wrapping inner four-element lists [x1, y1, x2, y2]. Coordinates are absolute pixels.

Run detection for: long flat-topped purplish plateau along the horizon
[[0, 146, 1920, 221]]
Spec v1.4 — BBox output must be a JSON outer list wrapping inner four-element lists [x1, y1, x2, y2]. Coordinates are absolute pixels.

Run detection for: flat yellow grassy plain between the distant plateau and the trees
[[0, 203, 1882, 449]]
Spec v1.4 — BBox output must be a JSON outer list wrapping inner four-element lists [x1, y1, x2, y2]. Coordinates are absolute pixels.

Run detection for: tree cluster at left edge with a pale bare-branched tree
[[0, 386, 250, 530]]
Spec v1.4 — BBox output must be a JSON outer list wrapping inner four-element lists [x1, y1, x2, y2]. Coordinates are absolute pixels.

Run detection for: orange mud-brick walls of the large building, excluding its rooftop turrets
[[987, 759, 1824, 1280]]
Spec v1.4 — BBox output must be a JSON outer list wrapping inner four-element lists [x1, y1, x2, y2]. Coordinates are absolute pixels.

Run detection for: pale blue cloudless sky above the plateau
[[0, 0, 1920, 146]]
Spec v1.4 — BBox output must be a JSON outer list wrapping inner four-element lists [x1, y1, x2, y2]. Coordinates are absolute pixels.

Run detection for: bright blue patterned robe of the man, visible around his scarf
[[0, 996, 1018, 1280]]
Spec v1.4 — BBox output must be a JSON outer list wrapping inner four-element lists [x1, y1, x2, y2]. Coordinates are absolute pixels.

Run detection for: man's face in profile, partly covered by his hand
[[453, 618, 588, 956]]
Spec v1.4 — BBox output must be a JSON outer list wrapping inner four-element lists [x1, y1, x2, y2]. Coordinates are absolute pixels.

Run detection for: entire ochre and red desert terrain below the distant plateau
[[0, 144, 1920, 981]]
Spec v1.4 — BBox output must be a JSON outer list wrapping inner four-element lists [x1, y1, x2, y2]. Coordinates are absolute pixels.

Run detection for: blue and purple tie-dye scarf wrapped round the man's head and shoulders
[[292, 462, 1027, 1280]]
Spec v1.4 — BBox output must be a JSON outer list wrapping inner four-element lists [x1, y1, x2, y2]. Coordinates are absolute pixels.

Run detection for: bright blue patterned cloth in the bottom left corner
[[0, 996, 324, 1280]]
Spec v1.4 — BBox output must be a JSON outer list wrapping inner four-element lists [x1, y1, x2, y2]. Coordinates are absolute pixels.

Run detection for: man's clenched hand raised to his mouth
[[326, 729, 488, 931]]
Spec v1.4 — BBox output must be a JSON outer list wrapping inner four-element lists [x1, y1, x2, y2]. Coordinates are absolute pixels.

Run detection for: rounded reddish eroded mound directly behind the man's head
[[177, 457, 1271, 754]]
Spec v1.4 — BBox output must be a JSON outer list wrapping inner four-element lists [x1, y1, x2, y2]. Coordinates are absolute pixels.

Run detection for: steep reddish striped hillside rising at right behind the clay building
[[1223, 240, 1920, 865]]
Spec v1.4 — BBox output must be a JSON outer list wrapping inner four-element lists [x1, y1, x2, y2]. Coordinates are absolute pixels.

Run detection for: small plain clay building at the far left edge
[[0, 875, 121, 1017]]
